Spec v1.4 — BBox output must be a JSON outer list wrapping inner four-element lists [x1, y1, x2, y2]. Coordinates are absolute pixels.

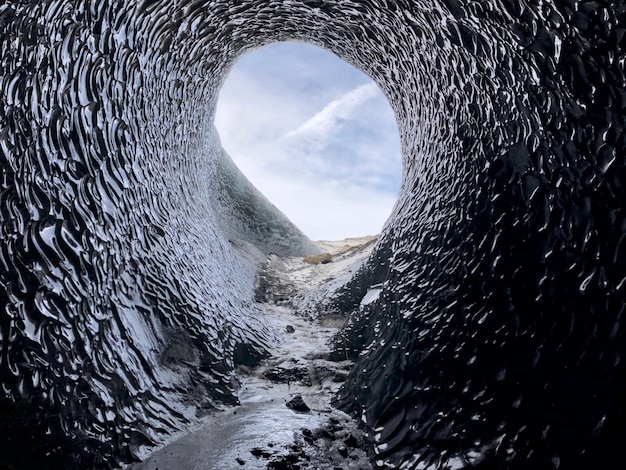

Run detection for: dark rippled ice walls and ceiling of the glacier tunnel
[[0, 0, 626, 468]]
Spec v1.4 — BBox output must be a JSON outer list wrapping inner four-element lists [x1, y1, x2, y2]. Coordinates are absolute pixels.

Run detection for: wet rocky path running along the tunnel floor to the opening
[[132, 237, 375, 470]]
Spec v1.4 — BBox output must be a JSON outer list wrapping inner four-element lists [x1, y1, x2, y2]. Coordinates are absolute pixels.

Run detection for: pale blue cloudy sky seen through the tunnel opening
[[215, 42, 402, 240]]
